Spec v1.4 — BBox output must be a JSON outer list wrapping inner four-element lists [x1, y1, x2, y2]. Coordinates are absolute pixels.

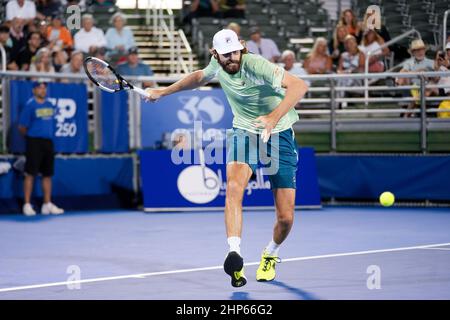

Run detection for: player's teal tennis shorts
[[227, 128, 298, 189]]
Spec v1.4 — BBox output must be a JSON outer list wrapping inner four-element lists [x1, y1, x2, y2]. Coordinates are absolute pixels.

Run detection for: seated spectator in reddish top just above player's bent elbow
[[304, 37, 333, 74]]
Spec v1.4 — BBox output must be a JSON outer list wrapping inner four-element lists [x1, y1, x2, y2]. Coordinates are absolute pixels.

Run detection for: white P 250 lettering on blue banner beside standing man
[[48, 98, 77, 137]]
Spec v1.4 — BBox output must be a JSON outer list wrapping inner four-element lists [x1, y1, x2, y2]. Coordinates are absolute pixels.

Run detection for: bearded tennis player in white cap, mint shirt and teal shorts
[[147, 29, 308, 287]]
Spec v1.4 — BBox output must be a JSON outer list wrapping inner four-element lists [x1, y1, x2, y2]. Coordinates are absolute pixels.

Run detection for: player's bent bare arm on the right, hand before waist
[[255, 72, 308, 135]]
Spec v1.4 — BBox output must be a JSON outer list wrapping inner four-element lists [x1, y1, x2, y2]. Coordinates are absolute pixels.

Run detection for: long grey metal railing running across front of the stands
[[0, 71, 450, 152]]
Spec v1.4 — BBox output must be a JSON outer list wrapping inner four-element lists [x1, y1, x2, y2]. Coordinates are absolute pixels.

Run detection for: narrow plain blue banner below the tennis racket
[[99, 90, 129, 153]]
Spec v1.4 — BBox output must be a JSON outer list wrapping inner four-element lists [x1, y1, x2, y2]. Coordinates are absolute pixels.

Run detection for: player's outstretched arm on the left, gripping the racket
[[146, 57, 220, 102]]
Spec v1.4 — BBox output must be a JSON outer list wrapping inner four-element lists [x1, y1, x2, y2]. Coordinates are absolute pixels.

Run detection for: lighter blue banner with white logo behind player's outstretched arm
[[141, 89, 233, 148]]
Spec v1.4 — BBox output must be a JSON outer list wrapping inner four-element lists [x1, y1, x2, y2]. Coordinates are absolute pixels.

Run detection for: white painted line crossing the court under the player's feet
[[0, 242, 450, 293]]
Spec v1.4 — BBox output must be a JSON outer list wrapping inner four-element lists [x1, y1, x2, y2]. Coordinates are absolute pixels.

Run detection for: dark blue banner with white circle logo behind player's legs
[[139, 148, 320, 211]]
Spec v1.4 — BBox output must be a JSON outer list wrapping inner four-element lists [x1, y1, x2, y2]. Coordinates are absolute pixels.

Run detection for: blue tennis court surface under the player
[[0, 207, 450, 300]]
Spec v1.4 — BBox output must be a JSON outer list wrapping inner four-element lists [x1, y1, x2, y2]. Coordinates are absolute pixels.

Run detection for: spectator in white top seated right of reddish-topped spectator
[[337, 34, 364, 101]]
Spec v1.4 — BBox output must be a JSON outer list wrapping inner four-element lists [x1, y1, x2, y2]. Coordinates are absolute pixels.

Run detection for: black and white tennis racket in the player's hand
[[83, 57, 148, 98]]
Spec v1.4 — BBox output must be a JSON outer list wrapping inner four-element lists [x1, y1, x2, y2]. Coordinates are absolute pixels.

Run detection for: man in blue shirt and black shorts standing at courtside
[[19, 82, 64, 216]]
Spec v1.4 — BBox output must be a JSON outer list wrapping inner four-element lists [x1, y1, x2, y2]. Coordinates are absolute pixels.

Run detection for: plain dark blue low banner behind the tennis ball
[[317, 155, 450, 201]]
